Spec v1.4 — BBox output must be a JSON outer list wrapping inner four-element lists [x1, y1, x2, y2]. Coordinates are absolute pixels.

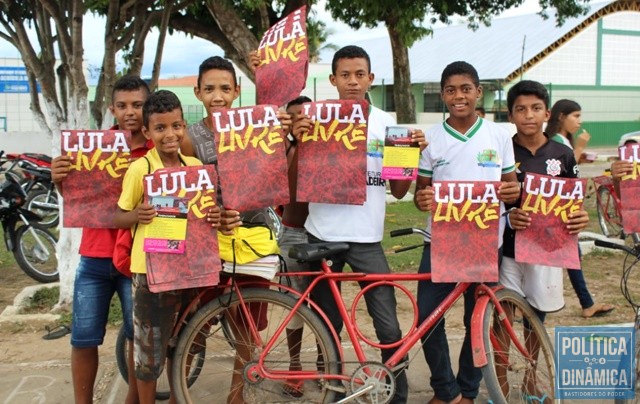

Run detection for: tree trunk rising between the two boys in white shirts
[[387, 20, 416, 123]]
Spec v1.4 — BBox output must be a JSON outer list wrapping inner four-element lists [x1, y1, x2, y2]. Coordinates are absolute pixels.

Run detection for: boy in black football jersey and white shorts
[[500, 80, 589, 321]]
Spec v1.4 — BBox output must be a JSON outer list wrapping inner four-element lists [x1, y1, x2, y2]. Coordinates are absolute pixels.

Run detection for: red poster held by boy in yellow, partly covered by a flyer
[[144, 165, 222, 293]]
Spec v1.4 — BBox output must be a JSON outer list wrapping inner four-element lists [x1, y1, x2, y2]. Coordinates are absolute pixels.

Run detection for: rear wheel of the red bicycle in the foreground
[[172, 289, 338, 403]]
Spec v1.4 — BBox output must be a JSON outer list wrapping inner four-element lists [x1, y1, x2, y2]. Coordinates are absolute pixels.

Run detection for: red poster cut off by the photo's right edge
[[618, 143, 640, 234]]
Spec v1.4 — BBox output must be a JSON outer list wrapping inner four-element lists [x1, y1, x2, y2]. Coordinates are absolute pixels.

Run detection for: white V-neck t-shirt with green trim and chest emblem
[[418, 117, 515, 245]]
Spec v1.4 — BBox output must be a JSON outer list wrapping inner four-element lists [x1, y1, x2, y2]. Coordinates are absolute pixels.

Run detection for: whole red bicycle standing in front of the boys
[[172, 229, 555, 403]]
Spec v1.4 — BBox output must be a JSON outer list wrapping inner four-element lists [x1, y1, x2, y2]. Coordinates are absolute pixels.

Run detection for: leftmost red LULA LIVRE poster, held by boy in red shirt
[[60, 130, 131, 228]]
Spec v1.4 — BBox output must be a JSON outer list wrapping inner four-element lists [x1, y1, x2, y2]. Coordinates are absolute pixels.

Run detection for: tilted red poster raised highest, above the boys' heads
[[256, 6, 309, 106]]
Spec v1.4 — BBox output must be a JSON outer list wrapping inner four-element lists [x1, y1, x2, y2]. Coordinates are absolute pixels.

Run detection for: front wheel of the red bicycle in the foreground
[[482, 289, 555, 404]]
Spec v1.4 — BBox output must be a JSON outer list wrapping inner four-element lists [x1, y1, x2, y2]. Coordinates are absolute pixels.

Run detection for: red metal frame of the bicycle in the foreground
[[208, 260, 530, 386]]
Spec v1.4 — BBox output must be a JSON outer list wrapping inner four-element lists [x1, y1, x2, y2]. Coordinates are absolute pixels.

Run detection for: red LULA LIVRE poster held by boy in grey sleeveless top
[[212, 105, 289, 212]]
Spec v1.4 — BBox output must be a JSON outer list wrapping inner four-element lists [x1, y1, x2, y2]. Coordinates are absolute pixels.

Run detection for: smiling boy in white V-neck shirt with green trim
[[414, 62, 520, 403]]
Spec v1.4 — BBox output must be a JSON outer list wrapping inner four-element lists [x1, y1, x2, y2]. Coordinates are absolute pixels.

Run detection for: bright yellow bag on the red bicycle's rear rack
[[218, 224, 280, 264]]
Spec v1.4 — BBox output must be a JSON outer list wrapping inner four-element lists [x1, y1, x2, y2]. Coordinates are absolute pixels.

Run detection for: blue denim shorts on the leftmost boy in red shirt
[[71, 256, 133, 348]]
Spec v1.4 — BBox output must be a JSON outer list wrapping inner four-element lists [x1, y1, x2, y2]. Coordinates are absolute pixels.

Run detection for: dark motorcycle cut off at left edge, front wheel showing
[[0, 172, 59, 283]]
